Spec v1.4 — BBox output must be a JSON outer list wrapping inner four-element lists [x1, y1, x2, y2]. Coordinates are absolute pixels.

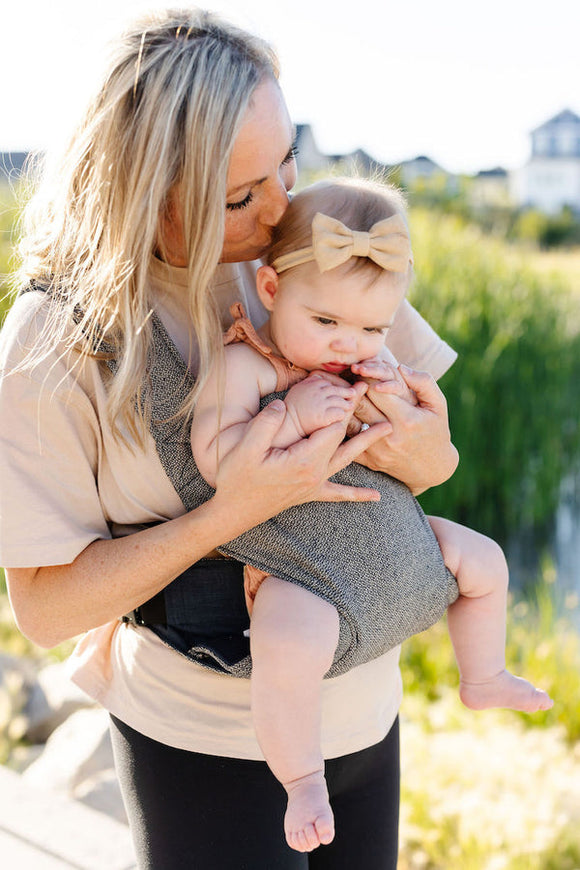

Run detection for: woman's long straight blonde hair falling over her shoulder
[[19, 9, 278, 443]]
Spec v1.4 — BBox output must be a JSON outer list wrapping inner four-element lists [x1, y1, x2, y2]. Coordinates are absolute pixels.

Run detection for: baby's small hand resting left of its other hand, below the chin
[[284, 372, 366, 438]]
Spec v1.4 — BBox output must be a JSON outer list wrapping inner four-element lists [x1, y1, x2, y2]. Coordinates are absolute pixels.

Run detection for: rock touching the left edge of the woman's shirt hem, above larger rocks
[[23, 662, 94, 743]]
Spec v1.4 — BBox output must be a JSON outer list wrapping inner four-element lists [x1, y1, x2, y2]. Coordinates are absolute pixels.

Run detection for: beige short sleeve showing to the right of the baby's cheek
[[386, 299, 457, 378]]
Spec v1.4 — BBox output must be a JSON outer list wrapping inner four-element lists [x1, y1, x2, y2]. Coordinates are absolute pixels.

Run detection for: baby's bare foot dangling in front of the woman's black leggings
[[284, 770, 334, 852]]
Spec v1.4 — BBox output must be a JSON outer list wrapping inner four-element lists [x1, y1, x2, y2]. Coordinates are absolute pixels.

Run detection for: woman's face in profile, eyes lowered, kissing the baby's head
[[221, 79, 296, 263]]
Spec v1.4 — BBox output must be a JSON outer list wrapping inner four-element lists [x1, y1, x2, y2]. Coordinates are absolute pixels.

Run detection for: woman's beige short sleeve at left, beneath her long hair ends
[[0, 293, 110, 567]]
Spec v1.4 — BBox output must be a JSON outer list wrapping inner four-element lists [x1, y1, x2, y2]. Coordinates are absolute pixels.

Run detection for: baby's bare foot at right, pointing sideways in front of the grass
[[459, 670, 554, 713]]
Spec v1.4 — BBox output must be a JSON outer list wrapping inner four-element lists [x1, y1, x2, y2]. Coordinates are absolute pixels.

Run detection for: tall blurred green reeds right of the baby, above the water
[[410, 210, 580, 543]]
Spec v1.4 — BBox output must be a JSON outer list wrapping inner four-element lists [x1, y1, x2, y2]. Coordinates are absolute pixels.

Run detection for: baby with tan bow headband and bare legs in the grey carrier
[[192, 180, 552, 851]]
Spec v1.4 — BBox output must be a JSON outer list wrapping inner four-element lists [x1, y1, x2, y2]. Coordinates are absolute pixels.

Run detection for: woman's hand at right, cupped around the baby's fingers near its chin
[[356, 365, 458, 495]]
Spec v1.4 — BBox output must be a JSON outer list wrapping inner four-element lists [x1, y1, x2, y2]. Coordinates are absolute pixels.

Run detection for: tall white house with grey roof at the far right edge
[[512, 109, 580, 214]]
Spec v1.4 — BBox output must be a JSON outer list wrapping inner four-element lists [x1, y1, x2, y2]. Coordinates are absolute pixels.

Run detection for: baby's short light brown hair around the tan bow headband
[[267, 177, 407, 280]]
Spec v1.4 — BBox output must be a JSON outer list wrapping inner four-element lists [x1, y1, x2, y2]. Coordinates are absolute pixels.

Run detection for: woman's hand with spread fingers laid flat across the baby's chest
[[212, 398, 392, 540]]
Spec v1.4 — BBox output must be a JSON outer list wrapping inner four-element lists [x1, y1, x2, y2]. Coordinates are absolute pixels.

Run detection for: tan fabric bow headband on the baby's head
[[272, 212, 413, 273]]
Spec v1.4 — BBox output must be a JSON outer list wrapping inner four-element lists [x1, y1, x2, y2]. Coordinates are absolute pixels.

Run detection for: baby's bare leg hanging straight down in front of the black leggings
[[250, 577, 339, 852]]
